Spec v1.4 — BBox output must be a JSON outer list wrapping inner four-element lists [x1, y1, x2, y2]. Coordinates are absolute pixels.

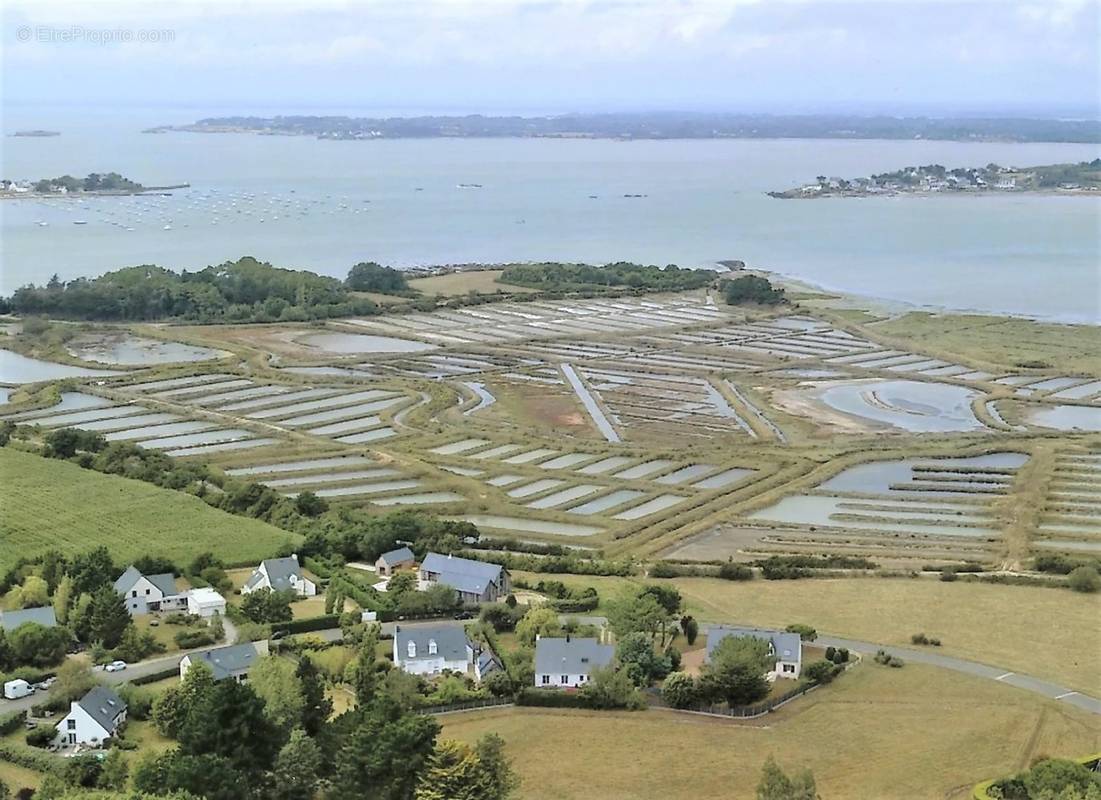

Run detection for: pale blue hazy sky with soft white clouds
[[0, 0, 1101, 121]]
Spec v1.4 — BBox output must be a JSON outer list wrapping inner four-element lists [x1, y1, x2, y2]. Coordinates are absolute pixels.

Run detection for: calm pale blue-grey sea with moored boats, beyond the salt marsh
[[0, 108, 1101, 325]]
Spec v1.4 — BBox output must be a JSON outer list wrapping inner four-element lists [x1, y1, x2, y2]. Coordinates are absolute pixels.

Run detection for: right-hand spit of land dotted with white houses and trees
[[768, 158, 1101, 200]]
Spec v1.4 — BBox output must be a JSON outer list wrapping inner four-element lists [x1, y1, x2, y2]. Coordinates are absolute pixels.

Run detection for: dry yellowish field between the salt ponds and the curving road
[[517, 573, 1101, 697]]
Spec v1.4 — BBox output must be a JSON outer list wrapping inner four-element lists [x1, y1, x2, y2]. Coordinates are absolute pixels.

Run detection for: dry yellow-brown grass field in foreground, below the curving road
[[440, 664, 1101, 800]]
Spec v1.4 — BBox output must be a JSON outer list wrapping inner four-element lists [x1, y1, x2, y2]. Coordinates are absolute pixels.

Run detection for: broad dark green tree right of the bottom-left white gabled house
[[176, 670, 283, 772]]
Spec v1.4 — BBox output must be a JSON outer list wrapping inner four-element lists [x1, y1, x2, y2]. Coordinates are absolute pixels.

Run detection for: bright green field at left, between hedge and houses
[[0, 448, 295, 569]]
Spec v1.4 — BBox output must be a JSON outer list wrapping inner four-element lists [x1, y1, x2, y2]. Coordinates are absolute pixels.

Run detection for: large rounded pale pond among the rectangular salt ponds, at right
[[819, 381, 983, 432]]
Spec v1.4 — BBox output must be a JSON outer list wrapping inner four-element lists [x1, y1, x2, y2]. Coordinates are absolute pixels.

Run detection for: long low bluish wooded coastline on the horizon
[[143, 112, 1101, 143]]
